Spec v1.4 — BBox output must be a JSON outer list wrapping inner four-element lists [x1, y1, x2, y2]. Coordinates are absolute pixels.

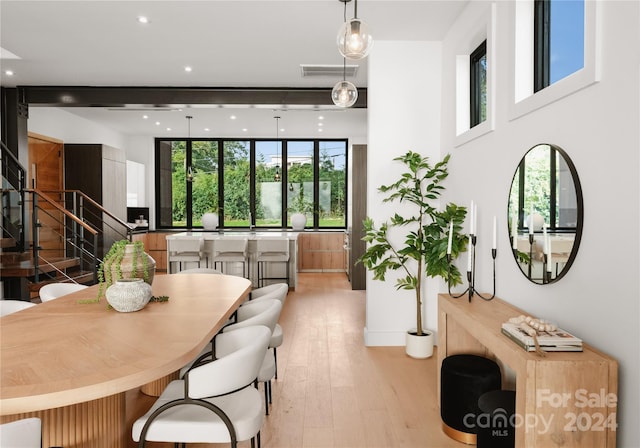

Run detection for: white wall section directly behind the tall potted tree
[[364, 41, 441, 345]]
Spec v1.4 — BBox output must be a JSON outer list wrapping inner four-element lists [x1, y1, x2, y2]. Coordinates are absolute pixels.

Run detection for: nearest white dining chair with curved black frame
[[131, 325, 271, 448]]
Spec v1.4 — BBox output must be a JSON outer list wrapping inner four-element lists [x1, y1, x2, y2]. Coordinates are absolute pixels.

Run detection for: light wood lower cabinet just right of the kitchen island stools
[[298, 232, 345, 272]]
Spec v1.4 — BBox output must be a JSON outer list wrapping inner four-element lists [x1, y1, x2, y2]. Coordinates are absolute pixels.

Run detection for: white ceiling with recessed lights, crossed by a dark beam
[[0, 0, 468, 138]]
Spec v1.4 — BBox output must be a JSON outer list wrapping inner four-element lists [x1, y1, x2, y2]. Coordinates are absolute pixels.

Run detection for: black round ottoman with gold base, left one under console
[[440, 354, 502, 445]]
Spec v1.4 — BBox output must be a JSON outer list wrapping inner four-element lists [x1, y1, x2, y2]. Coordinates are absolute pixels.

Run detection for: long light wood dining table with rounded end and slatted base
[[0, 274, 251, 448]]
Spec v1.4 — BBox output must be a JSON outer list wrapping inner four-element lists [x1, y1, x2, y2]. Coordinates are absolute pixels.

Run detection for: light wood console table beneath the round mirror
[[438, 294, 618, 448]]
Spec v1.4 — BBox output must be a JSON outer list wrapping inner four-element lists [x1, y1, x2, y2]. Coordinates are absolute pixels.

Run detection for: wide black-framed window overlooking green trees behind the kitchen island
[[156, 139, 347, 228]]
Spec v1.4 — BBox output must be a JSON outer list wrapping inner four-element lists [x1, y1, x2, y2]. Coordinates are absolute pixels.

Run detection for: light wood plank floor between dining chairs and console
[[127, 273, 467, 448]]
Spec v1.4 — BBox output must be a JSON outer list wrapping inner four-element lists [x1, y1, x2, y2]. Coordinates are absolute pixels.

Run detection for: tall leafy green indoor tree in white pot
[[358, 151, 467, 358]]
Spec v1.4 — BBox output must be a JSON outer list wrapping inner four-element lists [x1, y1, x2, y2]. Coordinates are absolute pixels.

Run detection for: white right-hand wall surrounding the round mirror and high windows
[[442, 1, 640, 447]]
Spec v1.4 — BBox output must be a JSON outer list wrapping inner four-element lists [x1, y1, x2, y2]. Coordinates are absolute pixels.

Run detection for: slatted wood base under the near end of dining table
[[0, 393, 129, 448]]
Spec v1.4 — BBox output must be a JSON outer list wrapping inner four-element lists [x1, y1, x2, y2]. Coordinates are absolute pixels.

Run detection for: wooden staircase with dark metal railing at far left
[[0, 142, 132, 300]]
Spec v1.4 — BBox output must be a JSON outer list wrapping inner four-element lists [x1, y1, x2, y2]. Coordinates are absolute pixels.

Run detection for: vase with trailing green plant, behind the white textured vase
[[97, 240, 156, 300]]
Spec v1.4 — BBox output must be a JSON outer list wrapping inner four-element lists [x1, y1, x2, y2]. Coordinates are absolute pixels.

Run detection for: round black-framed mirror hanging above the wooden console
[[507, 143, 584, 284]]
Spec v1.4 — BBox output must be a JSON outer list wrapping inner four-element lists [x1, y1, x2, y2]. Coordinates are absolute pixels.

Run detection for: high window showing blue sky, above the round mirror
[[534, 0, 585, 92]]
